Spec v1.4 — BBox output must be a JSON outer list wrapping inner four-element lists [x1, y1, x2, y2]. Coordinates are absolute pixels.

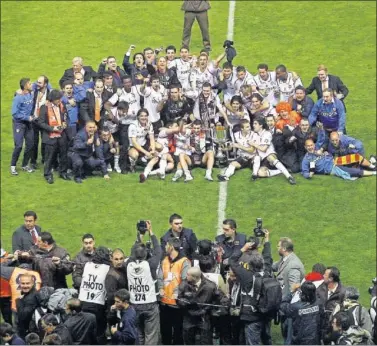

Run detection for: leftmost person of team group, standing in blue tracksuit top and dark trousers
[[10, 78, 34, 175]]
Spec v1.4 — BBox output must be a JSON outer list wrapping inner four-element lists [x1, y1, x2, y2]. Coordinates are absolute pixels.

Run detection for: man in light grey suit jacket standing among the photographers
[[272, 237, 305, 345]]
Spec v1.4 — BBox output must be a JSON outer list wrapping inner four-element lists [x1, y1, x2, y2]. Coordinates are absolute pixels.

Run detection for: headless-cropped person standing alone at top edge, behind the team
[[181, 0, 211, 52]]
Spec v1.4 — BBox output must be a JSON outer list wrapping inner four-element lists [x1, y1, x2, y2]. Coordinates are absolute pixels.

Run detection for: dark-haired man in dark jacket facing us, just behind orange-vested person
[[161, 214, 197, 260]]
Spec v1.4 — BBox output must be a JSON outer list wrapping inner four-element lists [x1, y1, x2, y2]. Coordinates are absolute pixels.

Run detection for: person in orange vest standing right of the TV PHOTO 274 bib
[[158, 237, 191, 345]]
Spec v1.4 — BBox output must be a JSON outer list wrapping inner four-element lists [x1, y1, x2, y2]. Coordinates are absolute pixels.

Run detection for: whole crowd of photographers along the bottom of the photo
[[0, 211, 377, 345]]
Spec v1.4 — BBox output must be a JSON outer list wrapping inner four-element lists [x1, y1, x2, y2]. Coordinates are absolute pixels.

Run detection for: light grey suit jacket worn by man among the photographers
[[272, 252, 305, 298]]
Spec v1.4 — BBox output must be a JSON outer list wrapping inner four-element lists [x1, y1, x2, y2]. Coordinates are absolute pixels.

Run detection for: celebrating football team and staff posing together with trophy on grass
[[10, 41, 376, 185]]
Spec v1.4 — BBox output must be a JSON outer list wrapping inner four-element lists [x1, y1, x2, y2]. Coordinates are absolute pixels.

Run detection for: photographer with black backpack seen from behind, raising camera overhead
[[229, 230, 282, 345]]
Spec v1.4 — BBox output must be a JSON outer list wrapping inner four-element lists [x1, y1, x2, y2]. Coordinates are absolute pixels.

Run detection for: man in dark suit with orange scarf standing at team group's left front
[[36, 90, 70, 184]]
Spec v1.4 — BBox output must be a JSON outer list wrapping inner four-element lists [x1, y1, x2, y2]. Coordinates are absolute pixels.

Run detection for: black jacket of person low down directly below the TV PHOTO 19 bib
[[64, 312, 97, 345]]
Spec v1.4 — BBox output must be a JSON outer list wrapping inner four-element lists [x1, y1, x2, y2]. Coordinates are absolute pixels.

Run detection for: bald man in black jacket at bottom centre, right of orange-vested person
[[178, 267, 228, 345]]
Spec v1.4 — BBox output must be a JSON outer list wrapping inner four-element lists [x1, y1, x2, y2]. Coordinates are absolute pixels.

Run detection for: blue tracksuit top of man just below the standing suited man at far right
[[309, 98, 346, 132]]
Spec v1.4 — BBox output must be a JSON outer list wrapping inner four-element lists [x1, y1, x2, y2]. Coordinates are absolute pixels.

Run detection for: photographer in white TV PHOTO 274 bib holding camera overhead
[[126, 220, 162, 345]]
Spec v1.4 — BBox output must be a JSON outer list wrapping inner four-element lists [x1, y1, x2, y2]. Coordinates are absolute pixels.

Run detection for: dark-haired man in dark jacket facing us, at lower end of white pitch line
[[215, 219, 246, 276]]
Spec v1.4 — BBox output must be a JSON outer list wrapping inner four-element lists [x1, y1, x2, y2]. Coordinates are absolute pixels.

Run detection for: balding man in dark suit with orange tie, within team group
[[80, 79, 105, 129]]
